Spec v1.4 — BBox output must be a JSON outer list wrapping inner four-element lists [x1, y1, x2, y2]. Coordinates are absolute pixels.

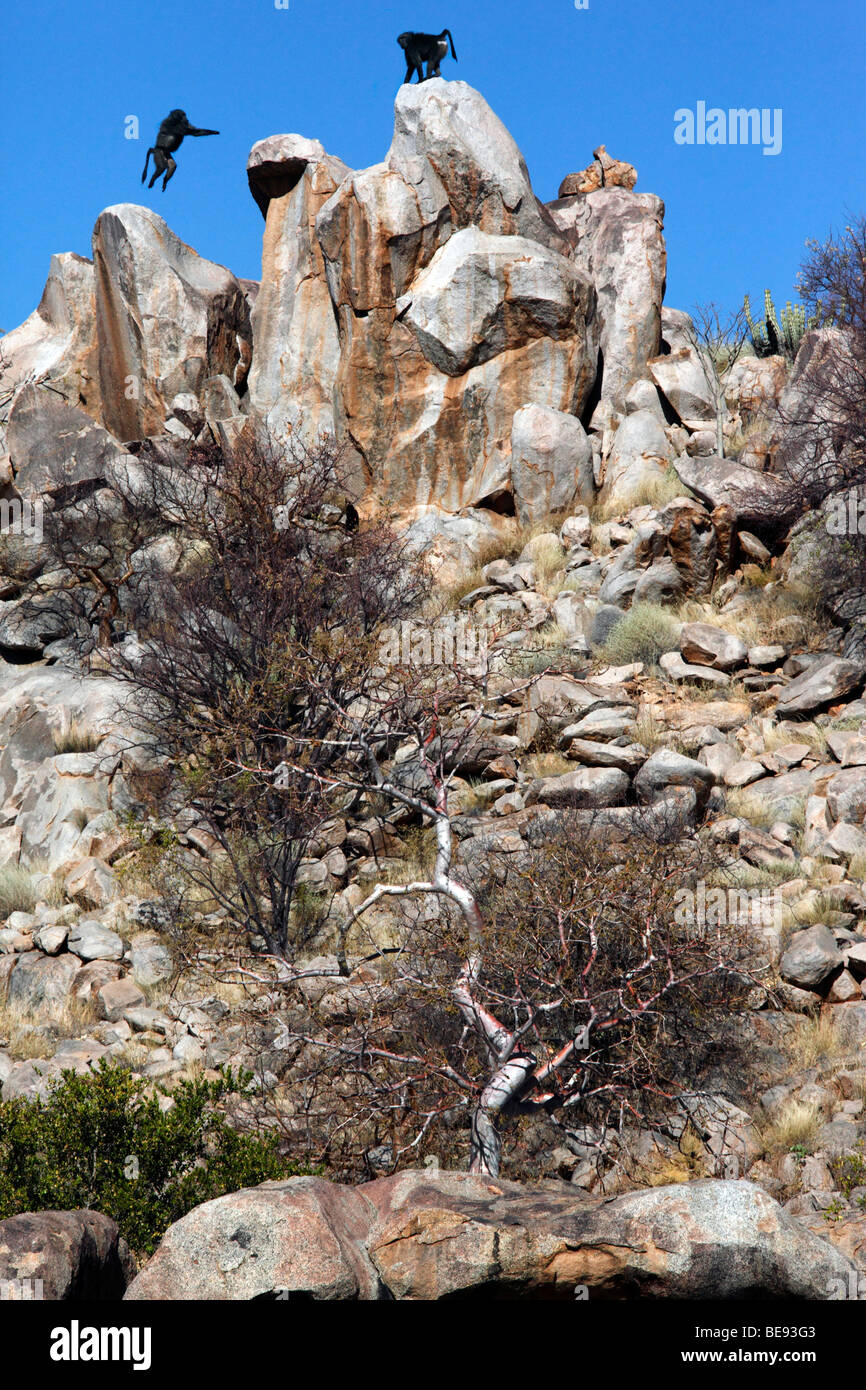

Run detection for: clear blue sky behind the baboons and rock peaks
[[0, 0, 866, 331]]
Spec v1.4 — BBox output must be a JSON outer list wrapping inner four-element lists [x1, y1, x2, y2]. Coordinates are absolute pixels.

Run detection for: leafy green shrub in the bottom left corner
[[0, 1058, 299, 1255]]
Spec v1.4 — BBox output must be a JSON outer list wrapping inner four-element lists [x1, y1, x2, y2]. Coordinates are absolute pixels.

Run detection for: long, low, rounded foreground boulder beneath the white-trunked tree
[[126, 1172, 856, 1301]]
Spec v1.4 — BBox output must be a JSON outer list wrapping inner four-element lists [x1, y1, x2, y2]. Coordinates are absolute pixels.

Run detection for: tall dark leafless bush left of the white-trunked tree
[[39, 430, 423, 958]]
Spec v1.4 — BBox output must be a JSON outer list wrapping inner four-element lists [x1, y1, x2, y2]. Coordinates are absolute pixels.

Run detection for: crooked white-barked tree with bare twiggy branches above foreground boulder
[[226, 687, 746, 1176]]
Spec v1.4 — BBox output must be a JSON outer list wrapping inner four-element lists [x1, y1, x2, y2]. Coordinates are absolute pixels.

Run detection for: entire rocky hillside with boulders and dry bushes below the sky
[[0, 78, 866, 1300]]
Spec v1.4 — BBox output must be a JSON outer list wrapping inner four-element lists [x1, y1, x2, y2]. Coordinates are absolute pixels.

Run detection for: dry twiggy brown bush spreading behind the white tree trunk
[[264, 816, 749, 1177]]
